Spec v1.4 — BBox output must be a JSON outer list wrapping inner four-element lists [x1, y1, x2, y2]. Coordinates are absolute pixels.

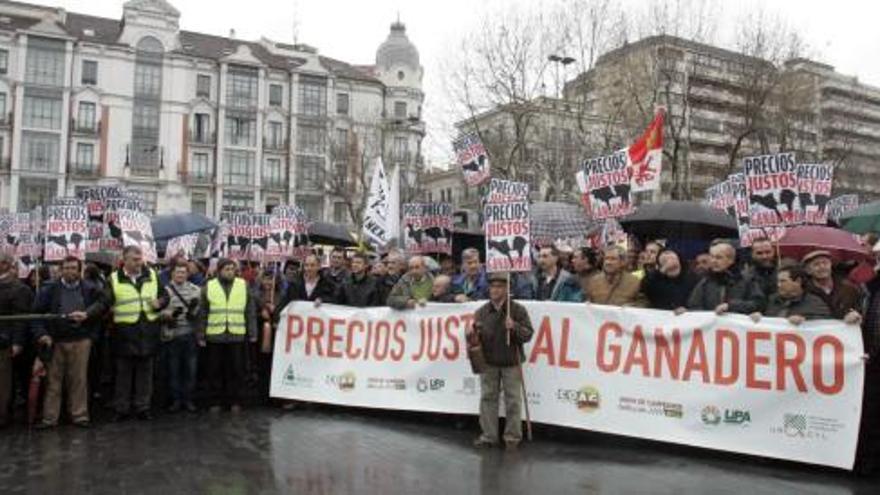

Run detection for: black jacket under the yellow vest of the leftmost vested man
[[101, 267, 168, 357]]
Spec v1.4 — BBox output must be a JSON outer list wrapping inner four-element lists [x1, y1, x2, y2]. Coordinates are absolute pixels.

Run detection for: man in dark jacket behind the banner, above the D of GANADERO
[[676, 241, 765, 315]]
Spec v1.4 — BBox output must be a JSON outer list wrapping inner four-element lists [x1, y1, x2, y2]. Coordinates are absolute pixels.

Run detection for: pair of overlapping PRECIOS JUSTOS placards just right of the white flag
[[403, 203, 452, 254]]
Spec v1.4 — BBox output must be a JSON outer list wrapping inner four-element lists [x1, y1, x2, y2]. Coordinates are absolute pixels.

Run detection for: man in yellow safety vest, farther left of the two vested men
[[104, 246, 168, 421]]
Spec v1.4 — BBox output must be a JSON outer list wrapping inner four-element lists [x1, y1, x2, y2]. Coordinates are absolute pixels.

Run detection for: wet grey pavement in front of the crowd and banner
[[0, 407, 880, 495]]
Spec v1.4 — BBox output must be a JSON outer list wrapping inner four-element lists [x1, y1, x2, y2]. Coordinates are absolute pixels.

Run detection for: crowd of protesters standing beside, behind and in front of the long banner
[[0, 239, 880, 472]]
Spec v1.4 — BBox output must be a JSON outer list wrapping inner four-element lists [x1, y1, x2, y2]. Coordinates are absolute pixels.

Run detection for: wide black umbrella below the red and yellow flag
[[620, 201, 739, 240]]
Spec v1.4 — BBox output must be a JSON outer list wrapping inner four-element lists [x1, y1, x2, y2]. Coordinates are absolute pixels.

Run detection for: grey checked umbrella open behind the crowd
[[529, 202, 593, 245]]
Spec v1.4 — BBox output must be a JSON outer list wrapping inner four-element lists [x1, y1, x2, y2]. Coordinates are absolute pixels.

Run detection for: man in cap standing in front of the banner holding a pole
[[468, 273, 534, 450]]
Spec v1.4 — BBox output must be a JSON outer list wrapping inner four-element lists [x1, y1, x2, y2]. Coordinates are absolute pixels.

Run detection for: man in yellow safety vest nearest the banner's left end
[[199, 259, 257, 413]]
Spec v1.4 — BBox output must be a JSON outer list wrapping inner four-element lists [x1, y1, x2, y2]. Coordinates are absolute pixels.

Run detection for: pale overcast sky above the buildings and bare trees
[[43, 0, 880, 166]]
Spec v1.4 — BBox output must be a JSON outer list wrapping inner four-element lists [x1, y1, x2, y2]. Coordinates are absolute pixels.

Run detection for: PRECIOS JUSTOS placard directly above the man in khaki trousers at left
[[43, 198, 89, 261]]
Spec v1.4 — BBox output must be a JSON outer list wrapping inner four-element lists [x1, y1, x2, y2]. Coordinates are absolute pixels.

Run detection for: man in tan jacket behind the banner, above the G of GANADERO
[[585, 245, 645, 307]]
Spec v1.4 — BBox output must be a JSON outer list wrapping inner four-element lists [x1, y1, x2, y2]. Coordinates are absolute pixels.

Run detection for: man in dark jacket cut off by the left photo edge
[[0, 254, 33, 428]]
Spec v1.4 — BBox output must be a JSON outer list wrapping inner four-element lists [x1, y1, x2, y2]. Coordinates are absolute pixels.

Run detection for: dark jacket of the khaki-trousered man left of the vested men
[[31, 280, 104, 342]]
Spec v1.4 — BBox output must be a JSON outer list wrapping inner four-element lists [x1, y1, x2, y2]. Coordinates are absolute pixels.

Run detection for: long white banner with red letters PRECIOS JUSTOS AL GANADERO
[[271, 302, 864, 469]]
